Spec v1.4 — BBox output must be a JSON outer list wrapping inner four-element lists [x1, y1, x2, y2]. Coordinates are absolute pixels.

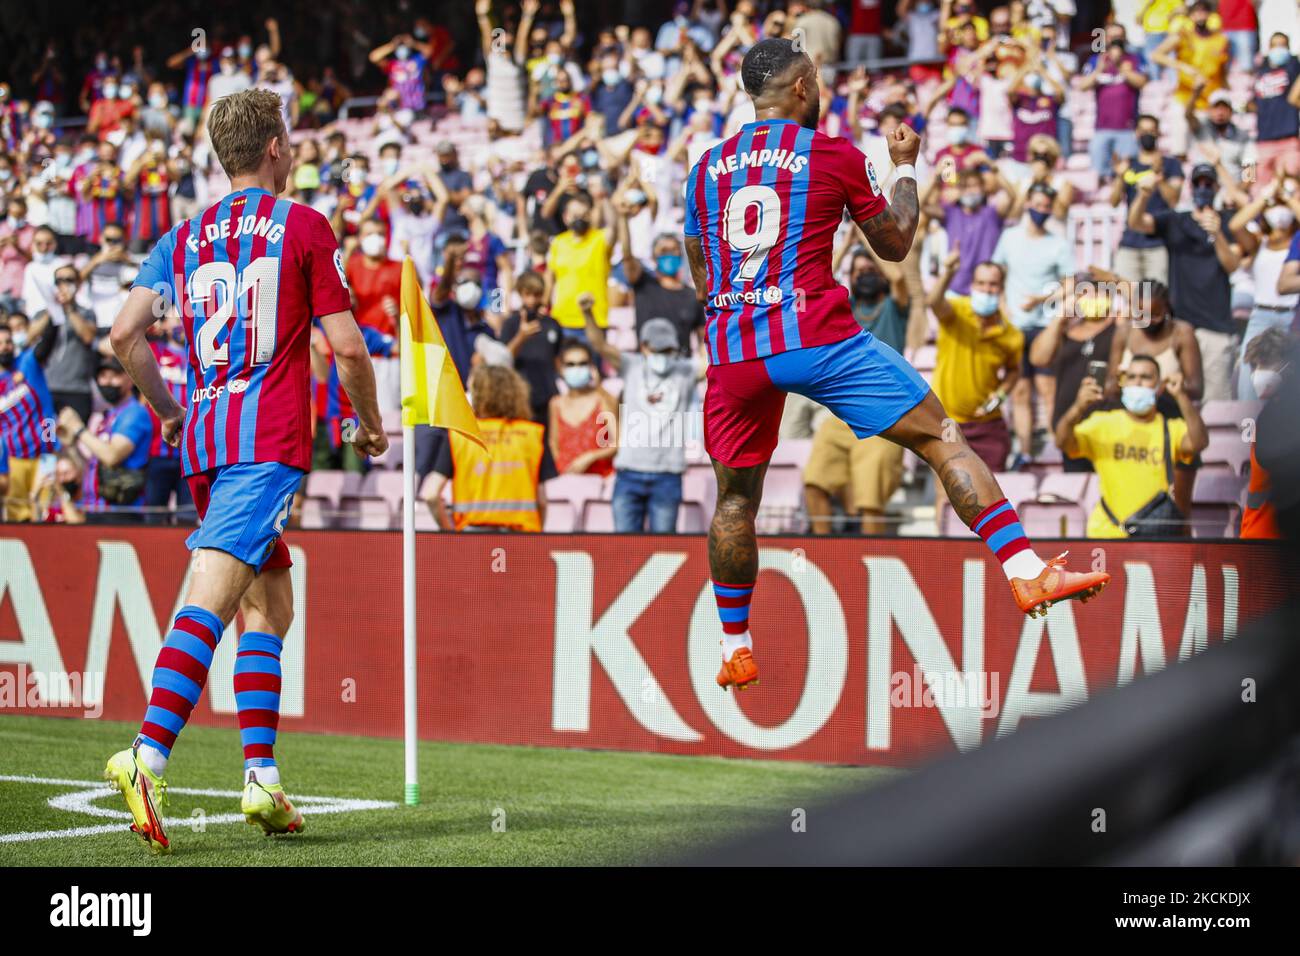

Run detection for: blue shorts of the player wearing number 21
[[185, 462, 307, 571]]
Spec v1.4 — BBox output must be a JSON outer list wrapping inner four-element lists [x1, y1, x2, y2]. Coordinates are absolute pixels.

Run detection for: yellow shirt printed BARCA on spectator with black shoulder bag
[[1073, 408, 1192, 537]]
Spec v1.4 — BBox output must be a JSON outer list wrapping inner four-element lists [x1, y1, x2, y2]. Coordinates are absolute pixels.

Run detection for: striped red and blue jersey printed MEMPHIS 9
[[685, 120, 887, 364]]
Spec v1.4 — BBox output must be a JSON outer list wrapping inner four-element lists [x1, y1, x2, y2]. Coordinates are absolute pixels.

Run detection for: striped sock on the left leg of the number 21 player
[[138, 605, 225, 775]]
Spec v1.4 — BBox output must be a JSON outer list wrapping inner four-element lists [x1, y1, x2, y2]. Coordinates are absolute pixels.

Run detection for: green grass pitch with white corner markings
[[0, 715, 893, 866]]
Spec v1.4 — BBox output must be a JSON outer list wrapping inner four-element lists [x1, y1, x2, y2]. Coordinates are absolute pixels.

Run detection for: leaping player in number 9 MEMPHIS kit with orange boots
[[685, 39, 1110, 689]]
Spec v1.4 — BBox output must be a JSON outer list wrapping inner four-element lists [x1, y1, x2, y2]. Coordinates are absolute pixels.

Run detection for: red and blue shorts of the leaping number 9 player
[[705, 330, 930, 468]]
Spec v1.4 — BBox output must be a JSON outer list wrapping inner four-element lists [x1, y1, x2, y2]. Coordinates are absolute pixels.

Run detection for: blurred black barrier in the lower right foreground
[[686, 602, 1300, 866]]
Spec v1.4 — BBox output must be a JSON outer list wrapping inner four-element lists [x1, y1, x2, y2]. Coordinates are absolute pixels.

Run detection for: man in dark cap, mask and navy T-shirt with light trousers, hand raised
[[1128, 163, 1242, 402]]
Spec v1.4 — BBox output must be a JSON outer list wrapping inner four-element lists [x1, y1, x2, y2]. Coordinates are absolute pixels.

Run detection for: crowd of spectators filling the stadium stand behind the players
[[0, 0, 1300, 537]]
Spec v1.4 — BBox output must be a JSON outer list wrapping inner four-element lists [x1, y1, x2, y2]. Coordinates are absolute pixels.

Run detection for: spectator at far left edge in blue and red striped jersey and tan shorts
[[0, 319, 56, 522]]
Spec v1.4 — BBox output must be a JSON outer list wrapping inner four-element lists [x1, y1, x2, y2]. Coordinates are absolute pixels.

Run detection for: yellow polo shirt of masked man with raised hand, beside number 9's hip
[[931, 295, 1024, 423]]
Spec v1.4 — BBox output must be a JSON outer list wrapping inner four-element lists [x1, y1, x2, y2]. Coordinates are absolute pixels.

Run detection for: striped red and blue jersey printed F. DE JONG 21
[[135, 187, 351, 475]]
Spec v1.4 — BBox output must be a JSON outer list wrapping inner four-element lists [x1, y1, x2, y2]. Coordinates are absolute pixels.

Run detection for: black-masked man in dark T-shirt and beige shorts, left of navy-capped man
[[1110, 114, 1183, 282]]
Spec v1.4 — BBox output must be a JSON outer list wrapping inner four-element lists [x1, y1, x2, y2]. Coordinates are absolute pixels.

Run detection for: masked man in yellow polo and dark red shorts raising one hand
[[930, 254, 1024, 478]]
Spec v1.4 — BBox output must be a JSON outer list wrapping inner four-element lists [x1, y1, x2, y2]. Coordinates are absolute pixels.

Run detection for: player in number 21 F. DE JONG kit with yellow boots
[[105, 90, 387, 852]]
